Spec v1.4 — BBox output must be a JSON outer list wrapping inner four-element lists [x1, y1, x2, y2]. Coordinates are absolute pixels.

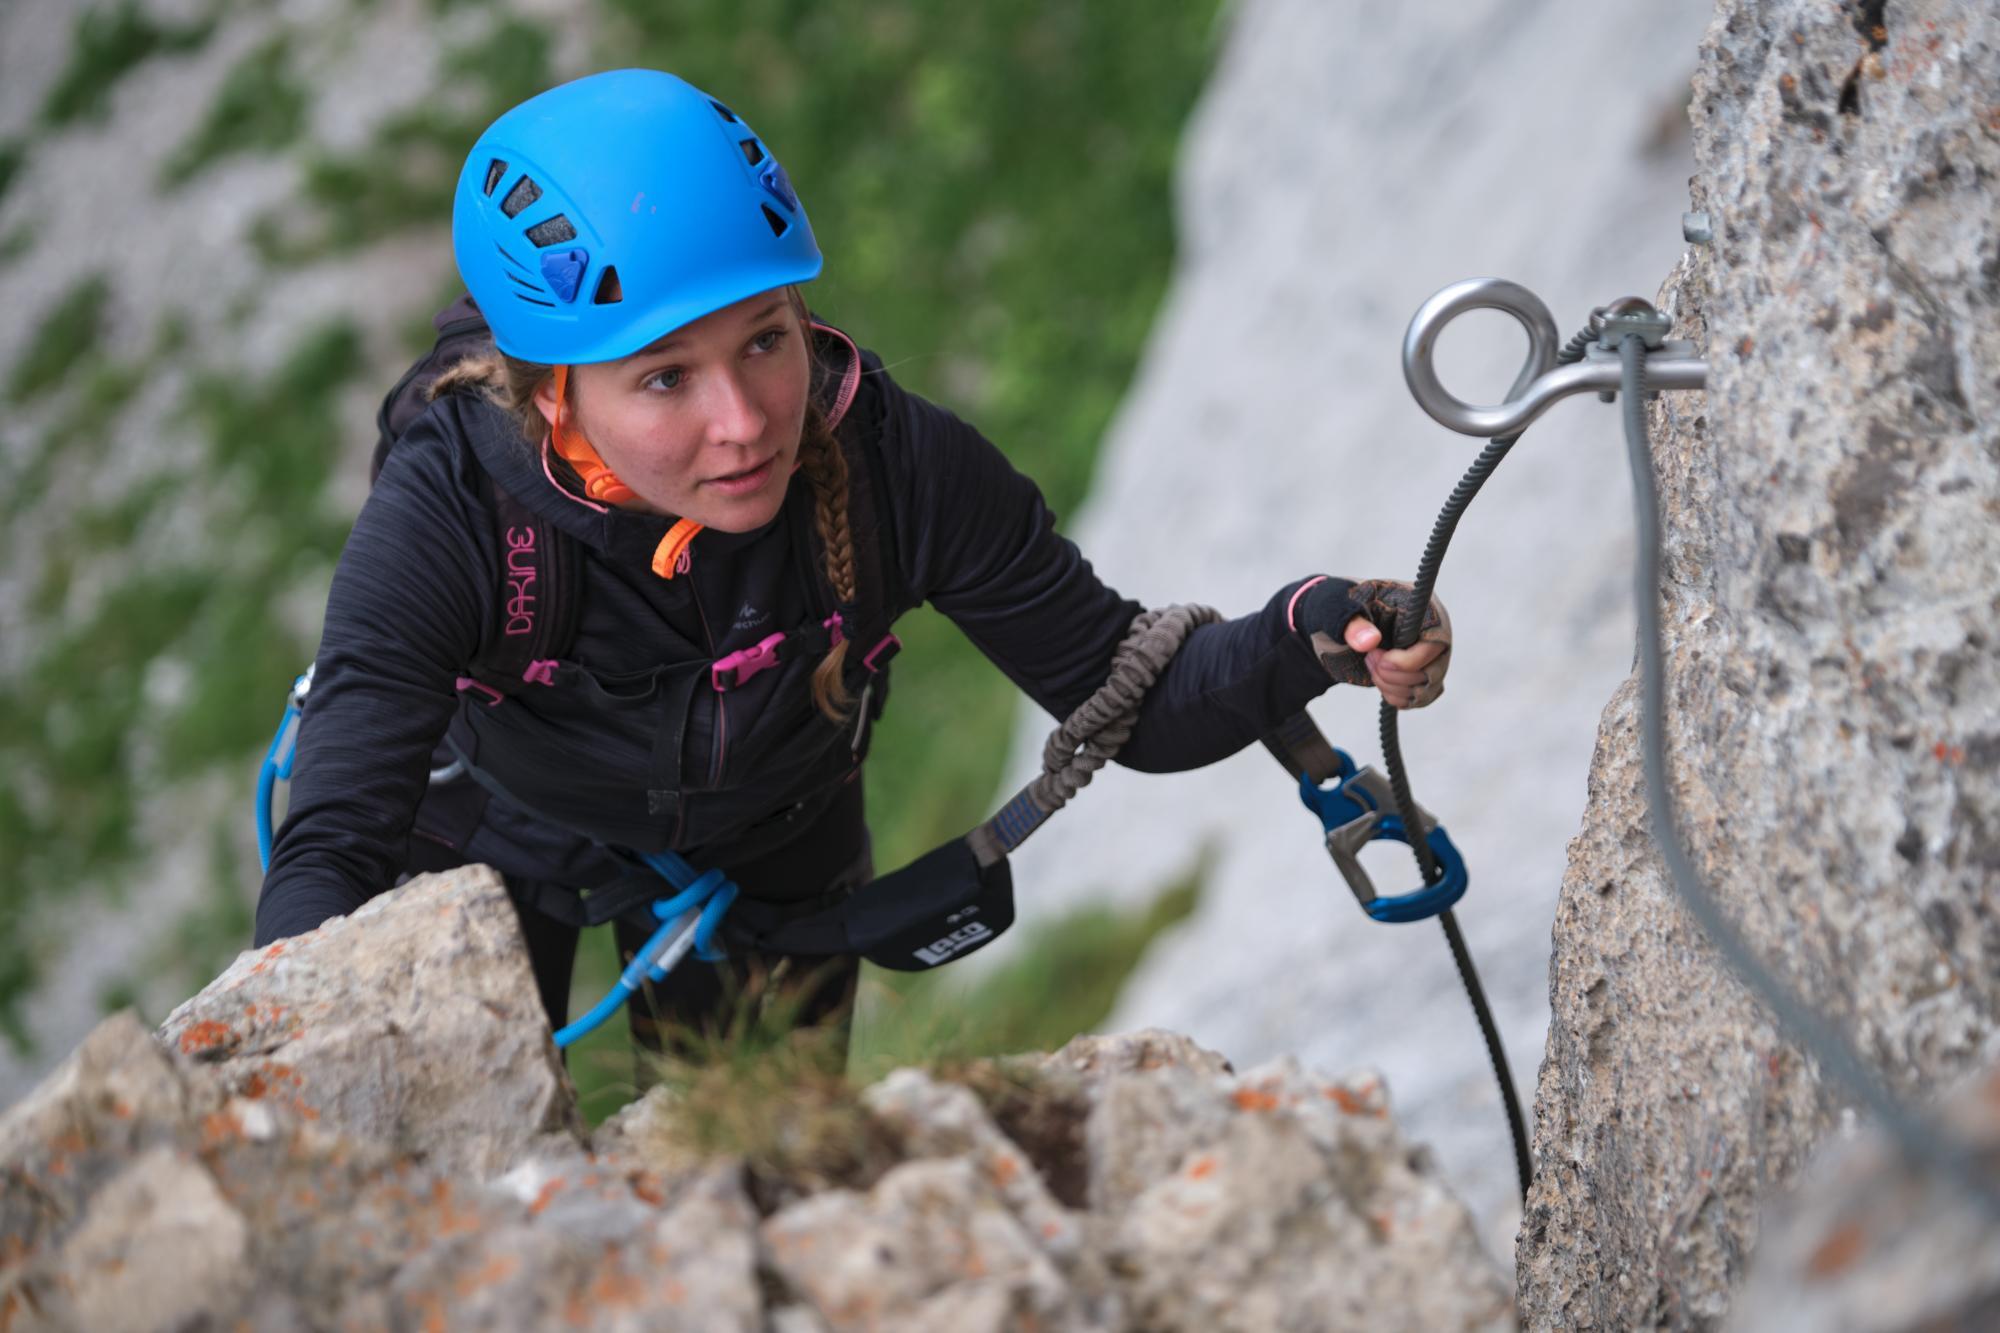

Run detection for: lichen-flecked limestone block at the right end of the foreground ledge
[[1090, 1061, 1514, 1333]]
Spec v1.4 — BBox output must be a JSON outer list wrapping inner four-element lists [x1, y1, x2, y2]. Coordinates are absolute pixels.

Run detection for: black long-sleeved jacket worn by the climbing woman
[[256, 338, 1328, 945]]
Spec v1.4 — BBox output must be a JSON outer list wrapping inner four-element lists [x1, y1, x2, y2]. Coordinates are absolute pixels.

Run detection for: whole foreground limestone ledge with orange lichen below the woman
[[0, 867, 1512, 1333]]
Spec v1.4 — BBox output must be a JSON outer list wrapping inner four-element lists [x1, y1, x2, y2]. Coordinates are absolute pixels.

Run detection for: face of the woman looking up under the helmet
[[534, 288, 810, 532]]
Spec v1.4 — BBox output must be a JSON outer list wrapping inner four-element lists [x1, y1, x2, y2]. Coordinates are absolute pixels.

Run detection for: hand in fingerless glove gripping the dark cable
[[1292, 578, 1452, 709]]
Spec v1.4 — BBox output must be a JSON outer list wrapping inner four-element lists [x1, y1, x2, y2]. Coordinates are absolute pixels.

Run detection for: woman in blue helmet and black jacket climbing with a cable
[[256, 70, 1450, 1072]]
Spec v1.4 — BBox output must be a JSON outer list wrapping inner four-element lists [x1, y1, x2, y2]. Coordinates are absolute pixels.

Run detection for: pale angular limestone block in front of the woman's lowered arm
[[160, 867, 582, 1175]]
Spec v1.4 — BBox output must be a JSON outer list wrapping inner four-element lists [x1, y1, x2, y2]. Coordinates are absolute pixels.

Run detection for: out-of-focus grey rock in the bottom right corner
[[1730, 1071, 2000, 1333]]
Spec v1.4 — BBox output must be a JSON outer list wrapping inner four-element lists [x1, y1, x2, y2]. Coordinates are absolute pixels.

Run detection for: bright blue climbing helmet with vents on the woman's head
[[452, 70, 822, 366]]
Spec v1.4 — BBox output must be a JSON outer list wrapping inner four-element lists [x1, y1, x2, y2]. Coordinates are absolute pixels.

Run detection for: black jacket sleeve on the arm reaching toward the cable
[[870, 370, 1330, 773]]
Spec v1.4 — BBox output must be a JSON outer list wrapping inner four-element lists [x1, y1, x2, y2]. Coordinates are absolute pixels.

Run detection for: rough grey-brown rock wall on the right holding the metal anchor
[[1518, 0, 2000, 1329]]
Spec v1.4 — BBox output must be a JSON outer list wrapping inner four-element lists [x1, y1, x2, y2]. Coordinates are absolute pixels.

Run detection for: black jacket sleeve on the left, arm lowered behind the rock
[[256, 414, 494, 947]]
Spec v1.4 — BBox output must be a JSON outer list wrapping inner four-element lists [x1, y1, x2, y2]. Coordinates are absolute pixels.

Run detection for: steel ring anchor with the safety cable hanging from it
[[1382, 278, 2000, 1217]]
